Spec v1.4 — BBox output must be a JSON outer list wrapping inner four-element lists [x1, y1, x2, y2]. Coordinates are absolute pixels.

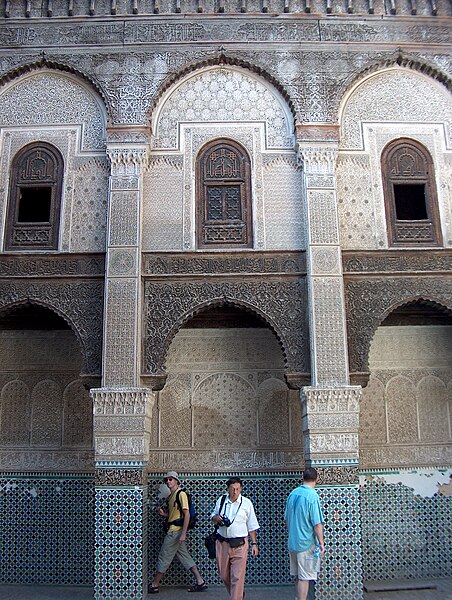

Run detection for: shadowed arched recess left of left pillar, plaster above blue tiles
[[0, 303, 93, 585]]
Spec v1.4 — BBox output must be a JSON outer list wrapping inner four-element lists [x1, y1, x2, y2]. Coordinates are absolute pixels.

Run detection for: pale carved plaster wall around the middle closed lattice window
[[147, 66, 296, 251]]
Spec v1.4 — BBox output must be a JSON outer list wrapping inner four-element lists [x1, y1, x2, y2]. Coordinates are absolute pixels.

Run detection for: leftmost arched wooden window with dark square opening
[[5, 143, 63, 250]]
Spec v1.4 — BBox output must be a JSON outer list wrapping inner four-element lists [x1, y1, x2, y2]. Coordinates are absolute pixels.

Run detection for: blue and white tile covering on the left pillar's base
[[94, 488, 147, 600]]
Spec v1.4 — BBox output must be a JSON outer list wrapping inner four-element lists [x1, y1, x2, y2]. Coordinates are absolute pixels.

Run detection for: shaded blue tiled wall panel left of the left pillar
[[0, 474, 94, 585]]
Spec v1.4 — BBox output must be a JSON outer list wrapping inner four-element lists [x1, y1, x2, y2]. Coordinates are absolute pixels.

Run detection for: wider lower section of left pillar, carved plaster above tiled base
[[91, 388, 154, 600]]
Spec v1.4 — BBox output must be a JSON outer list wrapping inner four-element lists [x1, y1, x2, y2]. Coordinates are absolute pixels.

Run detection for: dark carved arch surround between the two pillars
[[144, 281, 308, 375]]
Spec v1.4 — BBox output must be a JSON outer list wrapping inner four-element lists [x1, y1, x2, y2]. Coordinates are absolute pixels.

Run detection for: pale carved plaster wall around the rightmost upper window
[[337, 68, 452, 249]]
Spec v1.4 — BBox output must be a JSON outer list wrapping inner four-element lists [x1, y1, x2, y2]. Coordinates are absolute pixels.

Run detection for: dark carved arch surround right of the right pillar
[[345, 277, 452, 373]]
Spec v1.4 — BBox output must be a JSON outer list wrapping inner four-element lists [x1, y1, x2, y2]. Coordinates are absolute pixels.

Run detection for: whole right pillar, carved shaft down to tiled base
[[297, 126, 362, 600]]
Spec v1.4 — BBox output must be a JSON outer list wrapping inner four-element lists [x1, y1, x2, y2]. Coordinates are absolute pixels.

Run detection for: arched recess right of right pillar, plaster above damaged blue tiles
[[360, 300, 452, 580]]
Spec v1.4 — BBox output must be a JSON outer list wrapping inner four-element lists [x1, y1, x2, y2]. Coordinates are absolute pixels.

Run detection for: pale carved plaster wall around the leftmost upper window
[[0, 69, 108, 252]]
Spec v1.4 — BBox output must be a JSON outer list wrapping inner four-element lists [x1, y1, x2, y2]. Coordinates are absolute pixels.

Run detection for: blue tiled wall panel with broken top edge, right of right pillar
[[360, 480, 452, 580]]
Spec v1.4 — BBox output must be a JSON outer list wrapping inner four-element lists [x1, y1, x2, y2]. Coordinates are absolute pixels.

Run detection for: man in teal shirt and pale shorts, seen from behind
[[284, 467, 325, 600]]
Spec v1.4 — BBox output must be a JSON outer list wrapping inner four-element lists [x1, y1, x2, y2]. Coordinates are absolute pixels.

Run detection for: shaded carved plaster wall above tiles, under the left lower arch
[[0, 330, 93, 471]]
